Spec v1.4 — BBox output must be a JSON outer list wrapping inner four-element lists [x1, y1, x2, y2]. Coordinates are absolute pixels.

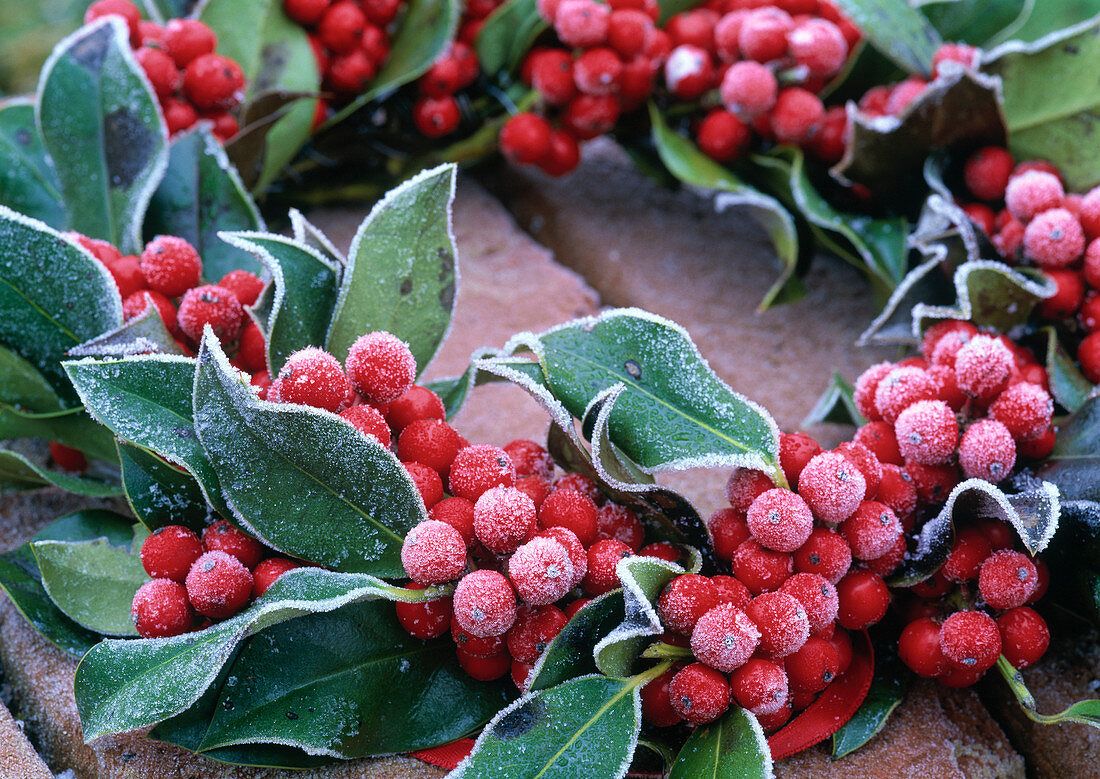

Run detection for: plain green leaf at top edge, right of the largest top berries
[[837, 0, 943, 76]]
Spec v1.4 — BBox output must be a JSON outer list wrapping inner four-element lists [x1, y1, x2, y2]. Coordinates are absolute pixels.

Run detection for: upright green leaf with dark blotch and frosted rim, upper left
[[37, 17, 168, 254]]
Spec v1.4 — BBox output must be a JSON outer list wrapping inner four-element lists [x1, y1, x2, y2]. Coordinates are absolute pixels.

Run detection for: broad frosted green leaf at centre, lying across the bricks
[[536, 309, 783, 483]]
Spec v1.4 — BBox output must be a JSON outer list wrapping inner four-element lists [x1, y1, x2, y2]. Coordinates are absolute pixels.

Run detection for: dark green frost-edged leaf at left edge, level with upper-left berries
[[0, 206, 122, 399]]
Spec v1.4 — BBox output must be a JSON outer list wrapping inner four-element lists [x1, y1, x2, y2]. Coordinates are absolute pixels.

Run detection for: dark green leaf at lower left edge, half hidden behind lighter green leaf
[[0, 509, 133, 658]]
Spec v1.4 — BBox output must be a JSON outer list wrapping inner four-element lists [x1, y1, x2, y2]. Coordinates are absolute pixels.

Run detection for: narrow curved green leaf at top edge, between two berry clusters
[[325, 0, 461, 128]]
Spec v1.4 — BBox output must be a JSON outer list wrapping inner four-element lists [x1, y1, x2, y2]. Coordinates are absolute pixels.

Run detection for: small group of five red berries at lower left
[[130, 519, 301, 638]]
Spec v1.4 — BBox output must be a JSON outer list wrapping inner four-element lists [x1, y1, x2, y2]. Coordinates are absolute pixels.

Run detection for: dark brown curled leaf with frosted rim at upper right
[[833, 65, 1007, 196]]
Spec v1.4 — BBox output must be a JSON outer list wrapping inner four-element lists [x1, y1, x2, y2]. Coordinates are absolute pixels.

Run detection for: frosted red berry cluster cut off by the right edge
[[961, 146, 1100, 384]]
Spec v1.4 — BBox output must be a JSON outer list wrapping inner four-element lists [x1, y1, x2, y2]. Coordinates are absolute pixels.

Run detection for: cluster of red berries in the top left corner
[[84, 0, 244, 142]]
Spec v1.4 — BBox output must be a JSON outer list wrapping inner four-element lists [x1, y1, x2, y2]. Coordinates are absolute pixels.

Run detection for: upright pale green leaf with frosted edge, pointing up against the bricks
[[325, 164, 459, 371]]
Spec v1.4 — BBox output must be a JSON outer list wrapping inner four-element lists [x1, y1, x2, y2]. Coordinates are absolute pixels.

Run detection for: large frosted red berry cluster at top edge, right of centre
[[501, 0, 860, 175]]
